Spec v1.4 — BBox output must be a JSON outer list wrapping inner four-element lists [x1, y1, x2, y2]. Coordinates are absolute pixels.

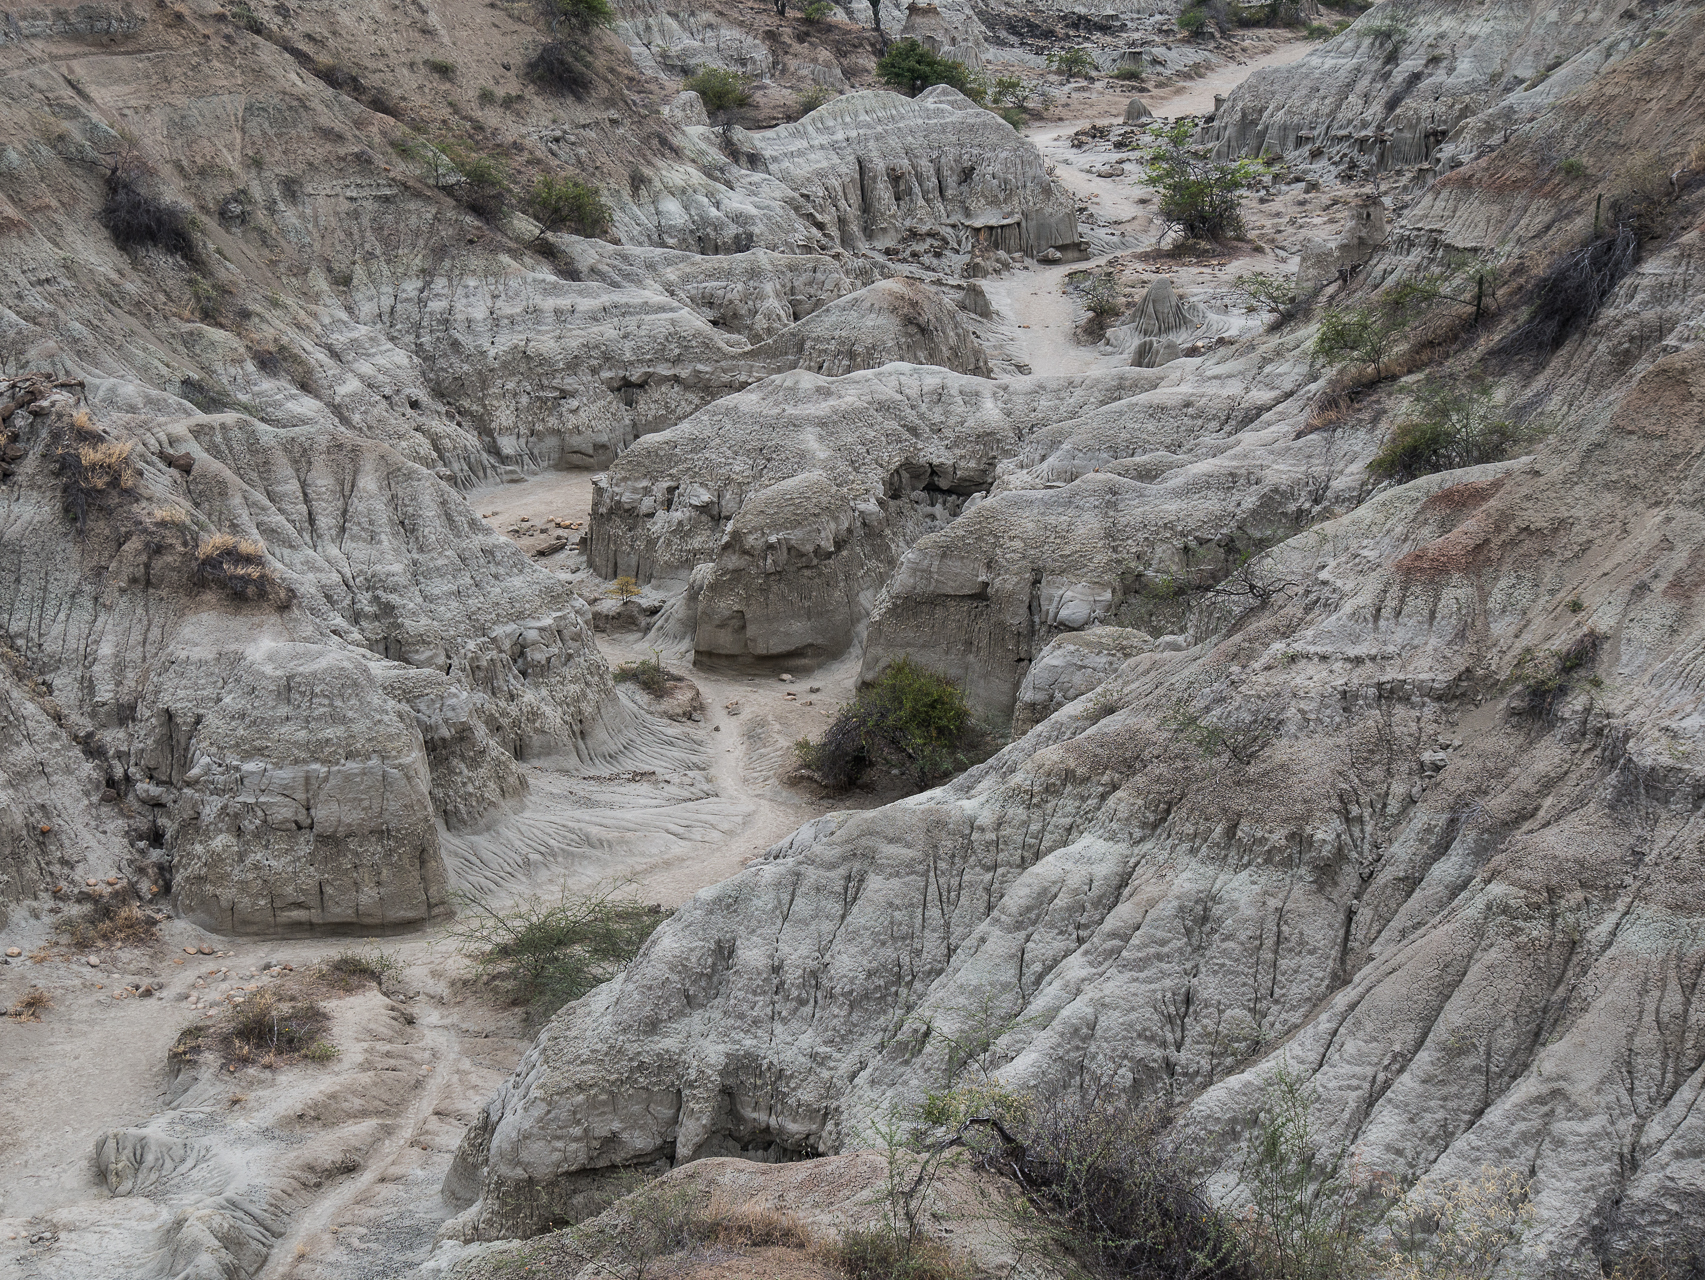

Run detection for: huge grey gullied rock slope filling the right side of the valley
[[450, 10, 1705, 1278]]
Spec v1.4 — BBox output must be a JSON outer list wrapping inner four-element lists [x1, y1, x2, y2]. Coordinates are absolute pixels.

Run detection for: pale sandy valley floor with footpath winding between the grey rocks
[[0, 43, 1344, 1280]]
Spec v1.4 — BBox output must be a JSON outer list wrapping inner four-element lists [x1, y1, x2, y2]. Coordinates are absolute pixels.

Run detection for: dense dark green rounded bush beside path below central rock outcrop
[[795, 658, 987, 791]]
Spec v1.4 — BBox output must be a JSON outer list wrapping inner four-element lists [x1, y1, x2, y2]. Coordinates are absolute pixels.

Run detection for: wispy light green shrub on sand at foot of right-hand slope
[[450, 891, 668, 1021]]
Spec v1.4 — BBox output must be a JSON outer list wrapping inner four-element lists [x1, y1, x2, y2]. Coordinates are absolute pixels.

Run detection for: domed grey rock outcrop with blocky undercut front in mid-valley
[[588, 363, 1158, 658]]
